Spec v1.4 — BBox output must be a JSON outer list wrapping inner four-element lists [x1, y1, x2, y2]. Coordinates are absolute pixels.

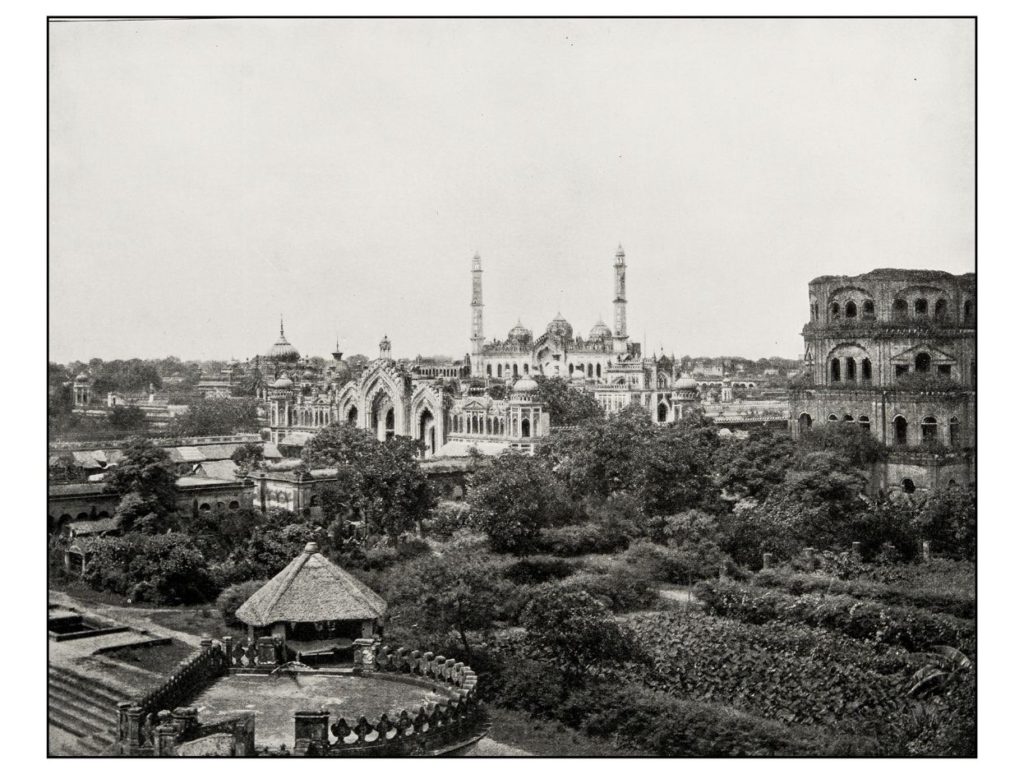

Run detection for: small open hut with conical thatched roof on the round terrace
[[236, 543, 387, 659]]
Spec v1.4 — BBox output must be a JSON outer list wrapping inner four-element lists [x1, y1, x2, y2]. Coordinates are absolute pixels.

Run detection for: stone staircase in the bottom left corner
[[48, 664, 130, 756]]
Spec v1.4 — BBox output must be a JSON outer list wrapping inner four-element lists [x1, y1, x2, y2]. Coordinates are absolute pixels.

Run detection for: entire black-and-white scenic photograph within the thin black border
[[39, 9, 991, 765]]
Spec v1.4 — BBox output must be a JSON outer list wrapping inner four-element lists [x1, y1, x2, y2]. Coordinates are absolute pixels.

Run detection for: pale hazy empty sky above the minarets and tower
[[49, 19, 974, 361]]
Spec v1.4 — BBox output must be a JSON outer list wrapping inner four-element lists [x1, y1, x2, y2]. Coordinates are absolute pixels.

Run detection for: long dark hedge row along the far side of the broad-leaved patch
[[695, 583, 975, 655]]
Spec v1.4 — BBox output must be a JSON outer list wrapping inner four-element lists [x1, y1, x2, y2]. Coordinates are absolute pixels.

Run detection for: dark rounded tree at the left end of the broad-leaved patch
[[521, 584, 639, 681]]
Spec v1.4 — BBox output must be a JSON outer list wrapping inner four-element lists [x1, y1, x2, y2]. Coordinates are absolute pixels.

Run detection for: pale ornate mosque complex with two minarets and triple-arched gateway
[[248, 246, 699, 457]]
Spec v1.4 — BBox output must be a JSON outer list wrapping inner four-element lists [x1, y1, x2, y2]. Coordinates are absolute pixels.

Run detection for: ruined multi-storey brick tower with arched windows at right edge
[[791, 269, 977, 491]]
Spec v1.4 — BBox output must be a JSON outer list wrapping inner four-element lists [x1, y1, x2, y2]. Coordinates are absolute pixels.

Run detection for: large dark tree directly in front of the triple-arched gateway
[[302, 425, 434, 543]]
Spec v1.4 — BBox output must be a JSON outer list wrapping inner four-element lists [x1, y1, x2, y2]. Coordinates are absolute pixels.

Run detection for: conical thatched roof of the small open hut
[[236, 543, 387, 627]]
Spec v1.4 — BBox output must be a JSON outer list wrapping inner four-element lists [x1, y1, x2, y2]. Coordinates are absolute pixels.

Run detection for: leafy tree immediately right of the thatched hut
[[388, 552, 512, 654]]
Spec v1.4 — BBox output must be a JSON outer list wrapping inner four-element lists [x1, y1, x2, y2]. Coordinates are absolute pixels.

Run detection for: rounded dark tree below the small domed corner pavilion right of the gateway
[[467, 452, 559, 555]]
